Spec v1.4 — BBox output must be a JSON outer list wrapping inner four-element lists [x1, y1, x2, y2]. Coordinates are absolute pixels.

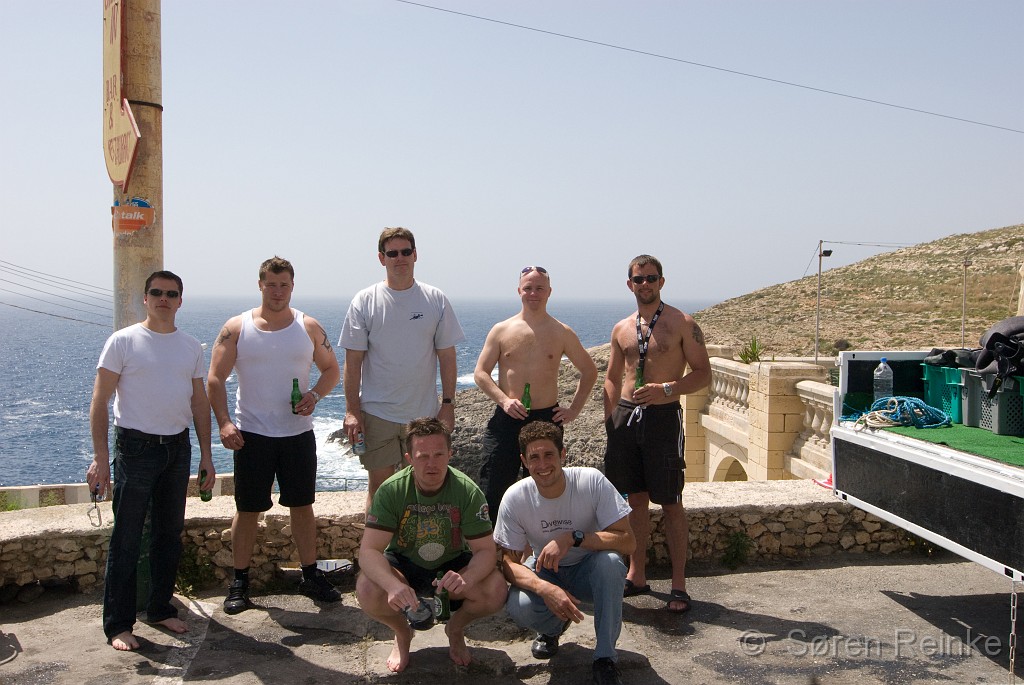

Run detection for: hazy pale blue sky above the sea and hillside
[[0, 0, 1024, 305]]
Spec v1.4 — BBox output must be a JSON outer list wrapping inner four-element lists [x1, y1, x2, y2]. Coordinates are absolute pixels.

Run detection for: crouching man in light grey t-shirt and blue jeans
[[495, 421, 636, 685]]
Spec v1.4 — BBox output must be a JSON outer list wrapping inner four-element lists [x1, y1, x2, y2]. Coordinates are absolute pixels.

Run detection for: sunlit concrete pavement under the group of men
[[0, 553, 1024, 685]]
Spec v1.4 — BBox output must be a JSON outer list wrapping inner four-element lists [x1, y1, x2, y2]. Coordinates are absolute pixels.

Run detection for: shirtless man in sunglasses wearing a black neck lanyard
[[604, 255, 711, 612]]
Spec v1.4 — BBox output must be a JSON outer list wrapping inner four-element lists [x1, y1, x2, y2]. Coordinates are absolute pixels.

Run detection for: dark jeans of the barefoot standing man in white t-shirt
[[103, 427, 191, 639]]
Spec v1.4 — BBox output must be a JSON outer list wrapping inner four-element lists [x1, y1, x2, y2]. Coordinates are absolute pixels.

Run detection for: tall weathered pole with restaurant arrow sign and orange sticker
[[103, 0, 164, 330]]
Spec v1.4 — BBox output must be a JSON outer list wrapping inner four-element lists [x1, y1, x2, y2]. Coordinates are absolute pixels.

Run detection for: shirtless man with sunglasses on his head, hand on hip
[[473, 266, 597, 521]]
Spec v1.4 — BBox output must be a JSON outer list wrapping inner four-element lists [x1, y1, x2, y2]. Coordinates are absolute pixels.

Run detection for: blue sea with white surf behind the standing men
[[0, 296, 714, 490]]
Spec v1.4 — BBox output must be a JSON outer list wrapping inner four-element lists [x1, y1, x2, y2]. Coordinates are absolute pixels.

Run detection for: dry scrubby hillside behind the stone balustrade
[[694, 224, 1024, 358]]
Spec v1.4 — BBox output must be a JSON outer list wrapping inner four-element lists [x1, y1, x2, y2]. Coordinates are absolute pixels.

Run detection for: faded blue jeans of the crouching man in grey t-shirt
[[505, 550, 626, 659]]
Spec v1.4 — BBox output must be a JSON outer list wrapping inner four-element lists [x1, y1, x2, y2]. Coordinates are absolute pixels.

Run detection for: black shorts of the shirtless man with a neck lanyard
[[604, 399, 686, 504]]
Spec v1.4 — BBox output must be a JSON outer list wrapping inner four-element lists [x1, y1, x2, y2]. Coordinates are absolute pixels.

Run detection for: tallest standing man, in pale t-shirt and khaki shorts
[[338, 227, 466, 511]]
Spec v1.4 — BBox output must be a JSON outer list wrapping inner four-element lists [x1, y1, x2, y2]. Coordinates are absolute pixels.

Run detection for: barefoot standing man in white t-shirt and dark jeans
[[86, 271, 216, 651]]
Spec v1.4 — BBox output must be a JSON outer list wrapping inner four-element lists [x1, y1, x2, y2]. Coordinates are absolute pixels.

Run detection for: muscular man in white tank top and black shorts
[[209, 257, 341, 613]]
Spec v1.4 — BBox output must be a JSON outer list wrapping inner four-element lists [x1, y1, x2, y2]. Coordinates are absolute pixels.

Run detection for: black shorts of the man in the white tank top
[[234, 430, 316, 512]]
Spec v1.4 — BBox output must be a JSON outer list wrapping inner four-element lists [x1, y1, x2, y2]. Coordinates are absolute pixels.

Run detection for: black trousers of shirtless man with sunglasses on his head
[[476, 405, 557, 516]]
